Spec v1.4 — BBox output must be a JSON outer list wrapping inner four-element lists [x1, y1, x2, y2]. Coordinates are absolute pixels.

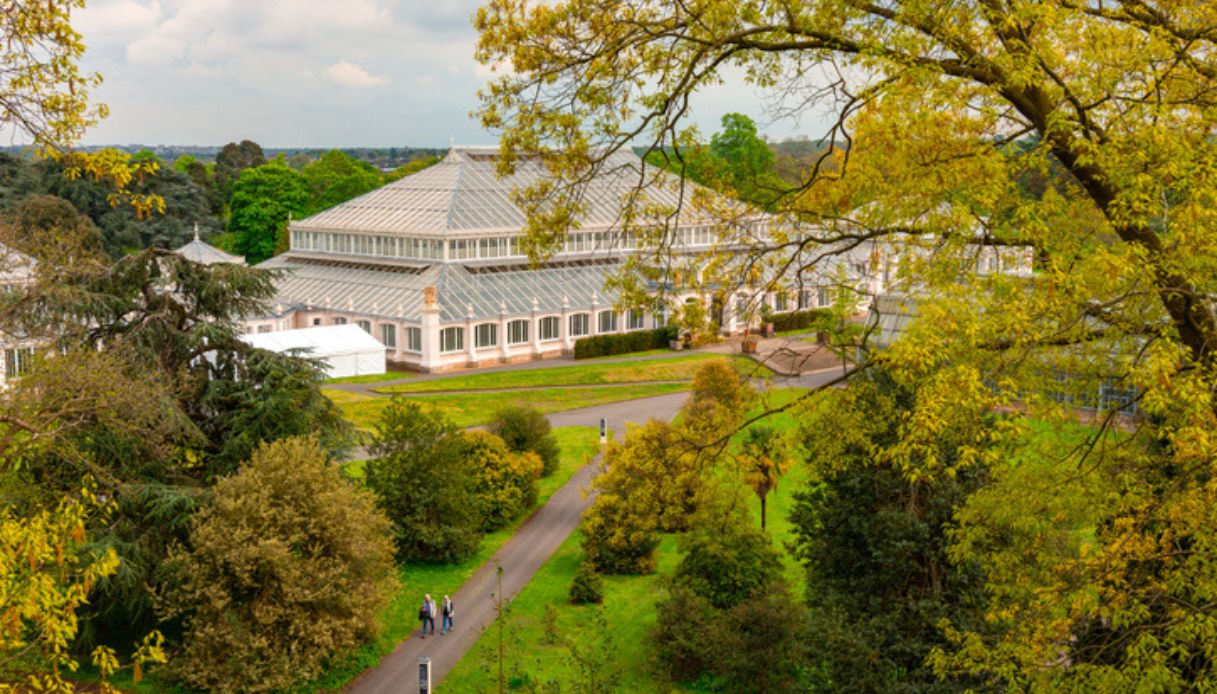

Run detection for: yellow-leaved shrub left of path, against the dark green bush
[[462, 431, 544, 532]]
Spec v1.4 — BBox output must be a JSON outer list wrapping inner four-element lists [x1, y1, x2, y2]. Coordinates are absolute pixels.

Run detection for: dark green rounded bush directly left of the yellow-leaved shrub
[[366, 398, 482, 561]]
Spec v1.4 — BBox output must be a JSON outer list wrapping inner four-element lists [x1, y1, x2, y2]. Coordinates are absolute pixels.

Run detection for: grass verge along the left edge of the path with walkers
[[296, 426, 600, 692]]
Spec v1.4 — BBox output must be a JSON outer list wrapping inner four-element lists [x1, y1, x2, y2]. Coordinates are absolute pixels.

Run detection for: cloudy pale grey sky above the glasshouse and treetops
[[73, 0, 820, 147]]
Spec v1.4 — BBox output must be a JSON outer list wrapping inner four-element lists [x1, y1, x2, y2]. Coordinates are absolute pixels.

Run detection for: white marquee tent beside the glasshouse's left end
[[241, 324, 385, 379]]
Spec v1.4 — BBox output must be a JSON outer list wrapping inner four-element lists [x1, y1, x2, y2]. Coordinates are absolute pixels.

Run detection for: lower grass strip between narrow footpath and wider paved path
[[323, 384, 689, 431]]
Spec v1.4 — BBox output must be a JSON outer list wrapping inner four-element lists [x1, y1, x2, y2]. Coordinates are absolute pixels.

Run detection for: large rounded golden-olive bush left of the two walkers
[[164, 438, 396, 692]]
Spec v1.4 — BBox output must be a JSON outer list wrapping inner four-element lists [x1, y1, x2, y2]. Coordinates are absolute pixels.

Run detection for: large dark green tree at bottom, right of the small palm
[[790, 369, 1003, 692]]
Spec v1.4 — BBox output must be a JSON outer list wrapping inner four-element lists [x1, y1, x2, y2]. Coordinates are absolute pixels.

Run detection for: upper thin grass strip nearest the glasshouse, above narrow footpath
[[377, 354, 768, 393]]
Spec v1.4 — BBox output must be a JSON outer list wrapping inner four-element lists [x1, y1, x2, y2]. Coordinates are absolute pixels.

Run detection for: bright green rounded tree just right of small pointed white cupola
[[228, 162, 310, 264]]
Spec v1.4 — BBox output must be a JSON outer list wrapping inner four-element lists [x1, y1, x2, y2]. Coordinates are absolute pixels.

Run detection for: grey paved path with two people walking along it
[[347, 401, 686, 694]]
